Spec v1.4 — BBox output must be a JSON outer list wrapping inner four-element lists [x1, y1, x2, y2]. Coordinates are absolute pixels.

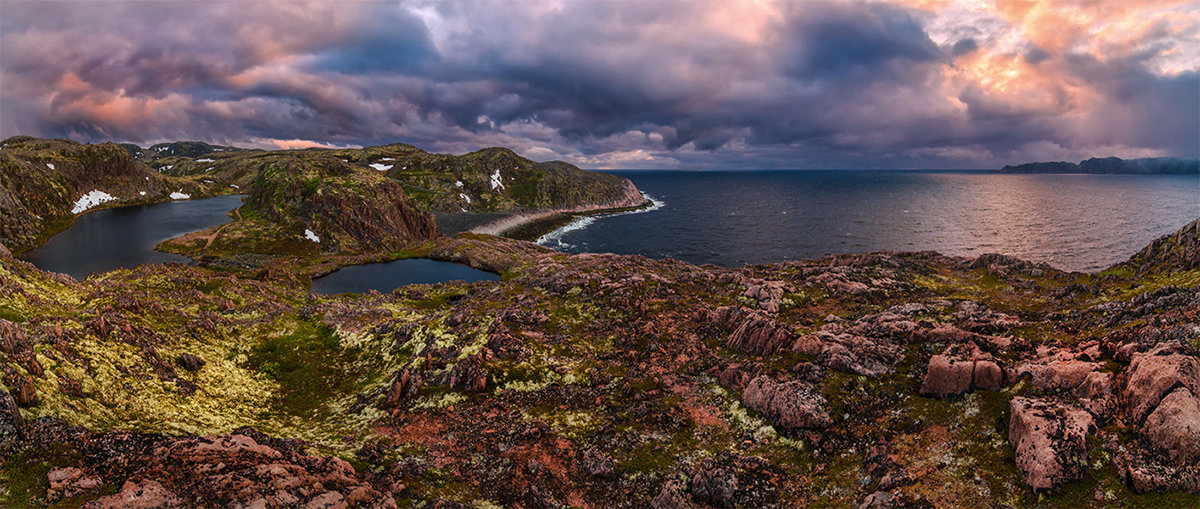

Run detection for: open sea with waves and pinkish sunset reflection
[[540, 170, 1200, 270]]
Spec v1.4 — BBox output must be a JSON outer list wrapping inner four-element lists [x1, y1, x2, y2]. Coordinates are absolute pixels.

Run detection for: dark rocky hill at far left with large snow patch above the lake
[[0, 137, 210, 250]]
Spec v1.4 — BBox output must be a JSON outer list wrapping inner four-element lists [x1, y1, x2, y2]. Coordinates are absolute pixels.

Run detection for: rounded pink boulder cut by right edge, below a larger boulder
[[1141, 387, 1200, 466]]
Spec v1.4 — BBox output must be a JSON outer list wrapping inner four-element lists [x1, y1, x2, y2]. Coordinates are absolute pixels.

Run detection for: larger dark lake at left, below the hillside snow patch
[[20, 196, 242, 279]]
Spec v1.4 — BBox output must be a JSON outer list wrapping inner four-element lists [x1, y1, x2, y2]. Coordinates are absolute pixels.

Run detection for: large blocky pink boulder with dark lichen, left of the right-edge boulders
[[1008, 397, 1094, 491]]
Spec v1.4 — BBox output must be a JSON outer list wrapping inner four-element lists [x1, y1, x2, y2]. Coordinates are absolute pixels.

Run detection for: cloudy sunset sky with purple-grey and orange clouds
[[0, 0, 1200, 169]]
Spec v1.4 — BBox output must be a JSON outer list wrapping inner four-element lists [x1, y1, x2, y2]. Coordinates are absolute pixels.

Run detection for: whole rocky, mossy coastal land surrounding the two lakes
[[0, 137, 1200, 508]]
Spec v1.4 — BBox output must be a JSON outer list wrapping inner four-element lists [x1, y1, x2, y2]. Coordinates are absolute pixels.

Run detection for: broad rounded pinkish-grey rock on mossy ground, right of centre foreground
[[742, 375, 833, 430]]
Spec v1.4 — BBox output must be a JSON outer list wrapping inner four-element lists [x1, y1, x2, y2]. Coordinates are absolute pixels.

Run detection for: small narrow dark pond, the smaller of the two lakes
[[312, 258, 500, 295]]
